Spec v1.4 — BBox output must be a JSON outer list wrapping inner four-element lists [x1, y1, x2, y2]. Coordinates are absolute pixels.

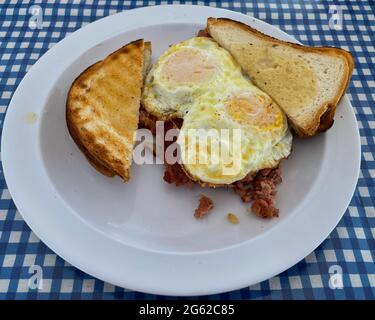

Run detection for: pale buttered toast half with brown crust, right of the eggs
[[207, 18, 354, 136]]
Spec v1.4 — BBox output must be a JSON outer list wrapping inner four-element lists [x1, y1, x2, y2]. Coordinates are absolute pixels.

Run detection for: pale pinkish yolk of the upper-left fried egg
[[161, 48, 215, 87]]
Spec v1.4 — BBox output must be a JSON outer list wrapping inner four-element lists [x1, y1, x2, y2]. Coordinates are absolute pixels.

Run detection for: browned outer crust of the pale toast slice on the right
[[207, 18, 354, 136]]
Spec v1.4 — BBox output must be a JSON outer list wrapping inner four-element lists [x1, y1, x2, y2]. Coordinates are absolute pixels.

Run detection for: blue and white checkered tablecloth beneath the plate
[[0, 0, 375, 299]]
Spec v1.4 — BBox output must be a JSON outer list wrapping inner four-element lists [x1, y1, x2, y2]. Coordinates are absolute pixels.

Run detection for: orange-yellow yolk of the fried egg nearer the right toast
[[226, 95, 283, 129]]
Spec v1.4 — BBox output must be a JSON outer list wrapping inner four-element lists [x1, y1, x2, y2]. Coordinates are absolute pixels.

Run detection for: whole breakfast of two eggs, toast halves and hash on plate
[[67, 18, 353, 220]]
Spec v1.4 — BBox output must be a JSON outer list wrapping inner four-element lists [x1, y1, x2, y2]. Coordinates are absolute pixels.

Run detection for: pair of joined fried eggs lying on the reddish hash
[[142, 37, 292, 185]]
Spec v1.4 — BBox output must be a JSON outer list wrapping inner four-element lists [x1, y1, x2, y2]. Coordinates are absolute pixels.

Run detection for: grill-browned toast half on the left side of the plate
[[66, 40, 151, 181]]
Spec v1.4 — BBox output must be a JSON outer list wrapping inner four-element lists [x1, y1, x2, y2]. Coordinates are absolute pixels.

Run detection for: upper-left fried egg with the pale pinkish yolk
[[142, 37, 242, 120]]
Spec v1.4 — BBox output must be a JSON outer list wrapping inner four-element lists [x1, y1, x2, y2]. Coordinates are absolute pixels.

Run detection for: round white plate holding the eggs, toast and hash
[[2, 6, 360, 295]]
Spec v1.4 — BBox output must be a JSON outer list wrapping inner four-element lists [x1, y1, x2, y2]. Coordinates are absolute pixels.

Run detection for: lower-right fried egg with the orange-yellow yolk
[[177, 90, 292, 185]]
